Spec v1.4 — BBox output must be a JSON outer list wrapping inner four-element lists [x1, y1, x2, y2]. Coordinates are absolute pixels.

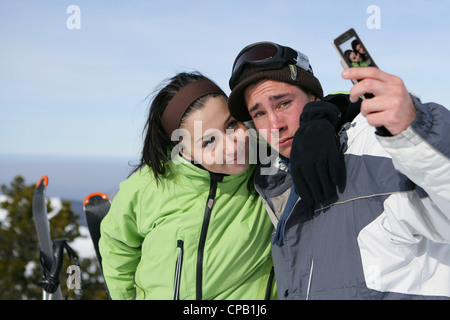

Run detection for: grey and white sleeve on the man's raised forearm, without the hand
[[378, 99, 450, 215]]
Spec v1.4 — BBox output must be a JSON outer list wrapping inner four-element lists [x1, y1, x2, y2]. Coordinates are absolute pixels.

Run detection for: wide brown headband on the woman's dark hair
[[162, 79, 226, 138]]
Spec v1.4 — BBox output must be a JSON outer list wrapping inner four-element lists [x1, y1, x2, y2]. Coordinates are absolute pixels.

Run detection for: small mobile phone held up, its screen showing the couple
[[333, 29, 377, 74]]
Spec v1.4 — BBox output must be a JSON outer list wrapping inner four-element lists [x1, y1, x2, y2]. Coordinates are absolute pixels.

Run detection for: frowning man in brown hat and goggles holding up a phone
[[229, 42, 450, 299]]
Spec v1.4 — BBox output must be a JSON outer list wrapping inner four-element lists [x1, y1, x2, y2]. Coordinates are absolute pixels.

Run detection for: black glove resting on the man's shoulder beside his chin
[[290, 101, 346, 203]]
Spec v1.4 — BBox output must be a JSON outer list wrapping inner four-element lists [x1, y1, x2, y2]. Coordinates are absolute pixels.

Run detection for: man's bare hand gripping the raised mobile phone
[[342, 67, 416, 136]]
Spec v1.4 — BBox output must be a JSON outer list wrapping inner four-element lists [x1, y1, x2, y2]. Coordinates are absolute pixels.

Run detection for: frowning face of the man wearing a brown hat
[[244, 80, 314, 158]]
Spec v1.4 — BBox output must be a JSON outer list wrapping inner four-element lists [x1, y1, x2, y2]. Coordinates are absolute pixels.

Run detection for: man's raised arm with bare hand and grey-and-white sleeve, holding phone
[[343, 68, 450, 242]]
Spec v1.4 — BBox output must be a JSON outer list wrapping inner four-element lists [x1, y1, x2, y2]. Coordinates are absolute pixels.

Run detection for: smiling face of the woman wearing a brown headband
[[180, 97, 249, 174]]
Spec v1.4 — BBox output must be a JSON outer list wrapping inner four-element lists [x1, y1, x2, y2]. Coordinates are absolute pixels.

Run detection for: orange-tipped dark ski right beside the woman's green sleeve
[[83, 192, 111, 269]]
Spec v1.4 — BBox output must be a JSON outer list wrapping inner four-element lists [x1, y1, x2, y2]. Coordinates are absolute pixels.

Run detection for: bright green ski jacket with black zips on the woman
[[99, 157, 276, 300]]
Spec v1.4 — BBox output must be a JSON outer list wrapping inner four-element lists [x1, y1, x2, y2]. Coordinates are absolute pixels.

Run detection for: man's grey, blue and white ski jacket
[[255, 97, 450, 299]]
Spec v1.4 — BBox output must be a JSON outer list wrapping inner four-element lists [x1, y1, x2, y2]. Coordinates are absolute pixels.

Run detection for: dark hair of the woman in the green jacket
[[132, 72, 225, 180]]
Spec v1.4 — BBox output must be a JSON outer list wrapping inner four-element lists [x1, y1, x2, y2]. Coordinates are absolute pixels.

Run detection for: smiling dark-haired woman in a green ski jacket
[[100, 73, 276, 299]]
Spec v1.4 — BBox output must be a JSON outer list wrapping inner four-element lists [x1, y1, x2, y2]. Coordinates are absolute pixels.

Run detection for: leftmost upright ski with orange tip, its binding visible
[[32, 176, 62, 300]]
